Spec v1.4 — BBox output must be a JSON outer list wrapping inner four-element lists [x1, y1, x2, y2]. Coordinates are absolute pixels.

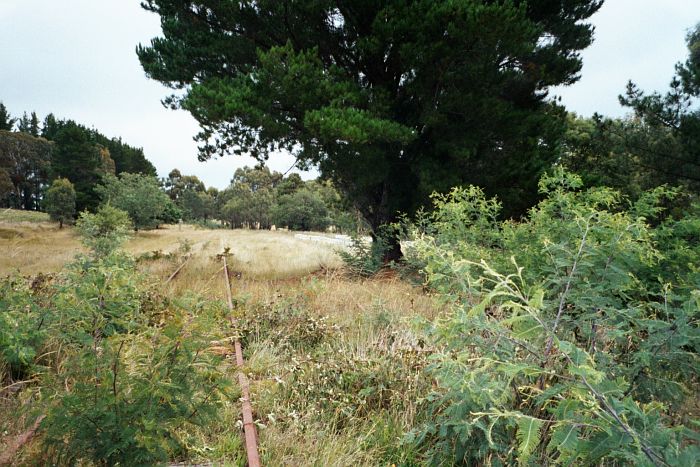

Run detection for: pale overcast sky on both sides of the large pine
[[0, 0, 700, 188]]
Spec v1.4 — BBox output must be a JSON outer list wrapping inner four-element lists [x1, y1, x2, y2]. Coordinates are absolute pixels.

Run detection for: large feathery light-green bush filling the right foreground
[[407, 170, 700, 465]]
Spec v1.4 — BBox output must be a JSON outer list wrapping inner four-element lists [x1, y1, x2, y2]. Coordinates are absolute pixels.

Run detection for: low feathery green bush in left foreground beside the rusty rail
[[43, 294, 228, 465]]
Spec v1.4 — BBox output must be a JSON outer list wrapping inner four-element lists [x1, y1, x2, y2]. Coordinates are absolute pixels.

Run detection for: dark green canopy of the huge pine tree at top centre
[[137, 0, 602, 249]]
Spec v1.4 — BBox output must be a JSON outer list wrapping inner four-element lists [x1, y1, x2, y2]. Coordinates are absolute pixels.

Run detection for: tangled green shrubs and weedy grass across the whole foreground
[[0, 170, 700, 466]]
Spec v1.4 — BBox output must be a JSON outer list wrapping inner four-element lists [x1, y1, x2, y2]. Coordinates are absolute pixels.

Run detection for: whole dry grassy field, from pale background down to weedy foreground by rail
[[0, 214, 439, 466]]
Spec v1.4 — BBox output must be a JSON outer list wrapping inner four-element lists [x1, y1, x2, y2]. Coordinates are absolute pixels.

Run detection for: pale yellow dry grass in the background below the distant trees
[[0, 221, 341, 278]]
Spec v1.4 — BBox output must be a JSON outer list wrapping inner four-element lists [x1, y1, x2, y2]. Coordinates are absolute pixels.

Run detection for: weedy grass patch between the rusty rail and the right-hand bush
[[230, 288, 430, 465]]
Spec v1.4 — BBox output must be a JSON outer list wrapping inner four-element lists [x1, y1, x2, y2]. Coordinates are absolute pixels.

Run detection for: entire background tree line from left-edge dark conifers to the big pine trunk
[[0, 103, 362, 231]]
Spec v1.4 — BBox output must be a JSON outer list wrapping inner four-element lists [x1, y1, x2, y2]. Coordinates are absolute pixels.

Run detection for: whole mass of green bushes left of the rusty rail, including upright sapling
[[0, 215, 229, 465]]
